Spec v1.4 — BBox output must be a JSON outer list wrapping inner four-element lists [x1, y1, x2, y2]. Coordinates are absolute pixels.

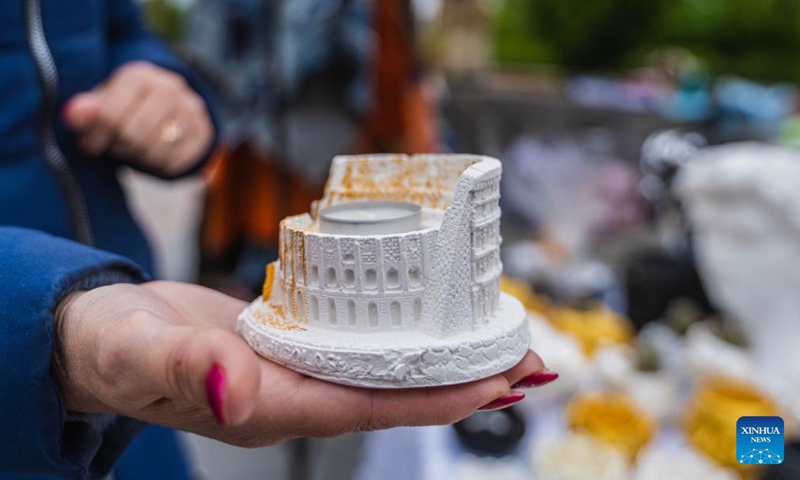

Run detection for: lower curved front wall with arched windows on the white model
[[278, 215, 438, 331]]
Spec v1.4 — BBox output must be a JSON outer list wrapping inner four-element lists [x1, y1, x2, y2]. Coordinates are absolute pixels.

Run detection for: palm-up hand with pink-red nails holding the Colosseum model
[[56, 282, 554, 447]]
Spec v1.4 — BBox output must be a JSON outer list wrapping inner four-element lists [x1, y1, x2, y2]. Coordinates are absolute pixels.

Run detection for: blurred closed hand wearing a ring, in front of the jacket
[[63, 62, 213, 176]]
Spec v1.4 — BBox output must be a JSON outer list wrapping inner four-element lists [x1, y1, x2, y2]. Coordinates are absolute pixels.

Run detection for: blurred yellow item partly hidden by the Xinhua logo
[[683, 377, 778, 476]]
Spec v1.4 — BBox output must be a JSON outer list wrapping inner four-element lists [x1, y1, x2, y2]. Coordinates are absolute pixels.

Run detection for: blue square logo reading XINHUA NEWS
[[736, 417, 784, 465]]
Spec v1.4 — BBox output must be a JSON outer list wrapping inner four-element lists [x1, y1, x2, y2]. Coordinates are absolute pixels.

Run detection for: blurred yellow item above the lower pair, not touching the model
[[545, 303, 634, 357]]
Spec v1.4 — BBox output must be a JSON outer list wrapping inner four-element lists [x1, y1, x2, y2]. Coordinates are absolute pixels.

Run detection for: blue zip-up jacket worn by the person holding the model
[[0, 0, 217, 478]]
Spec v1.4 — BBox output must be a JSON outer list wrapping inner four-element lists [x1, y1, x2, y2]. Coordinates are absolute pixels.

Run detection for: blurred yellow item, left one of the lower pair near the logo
[[566, 393, 655, 460]]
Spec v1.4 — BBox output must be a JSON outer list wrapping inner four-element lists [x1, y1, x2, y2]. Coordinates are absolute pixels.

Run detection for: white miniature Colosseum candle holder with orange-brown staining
[[237, 155, 530, 388]]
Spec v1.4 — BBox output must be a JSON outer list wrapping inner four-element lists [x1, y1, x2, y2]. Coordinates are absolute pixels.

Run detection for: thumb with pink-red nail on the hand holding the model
[[147, 326, 261, 425]]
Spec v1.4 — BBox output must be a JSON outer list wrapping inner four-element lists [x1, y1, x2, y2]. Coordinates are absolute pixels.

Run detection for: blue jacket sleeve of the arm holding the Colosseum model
[[0, 226, 145, 479]]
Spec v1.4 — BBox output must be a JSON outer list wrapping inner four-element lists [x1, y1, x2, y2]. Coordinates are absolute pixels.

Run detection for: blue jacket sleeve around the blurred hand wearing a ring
[[108, 0, 220, 179]]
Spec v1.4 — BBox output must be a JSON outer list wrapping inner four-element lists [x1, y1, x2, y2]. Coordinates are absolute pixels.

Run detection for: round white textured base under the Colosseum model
[[237, 294, 530, 388]]
